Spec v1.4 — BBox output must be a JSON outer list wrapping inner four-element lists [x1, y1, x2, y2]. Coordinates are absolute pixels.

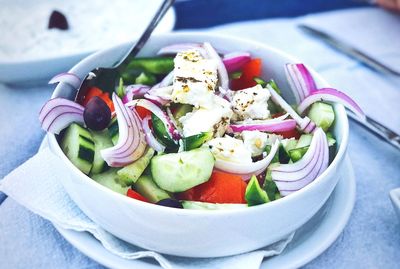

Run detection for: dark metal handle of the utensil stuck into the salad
[[113, 0, 175, 67]]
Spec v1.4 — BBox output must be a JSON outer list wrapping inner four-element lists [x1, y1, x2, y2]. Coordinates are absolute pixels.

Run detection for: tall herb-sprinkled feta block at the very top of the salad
[[172, 50, 218, 108]]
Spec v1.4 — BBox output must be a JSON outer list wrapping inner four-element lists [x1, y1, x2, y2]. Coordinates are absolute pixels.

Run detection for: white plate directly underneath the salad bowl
[[48, 137, 356, 269]]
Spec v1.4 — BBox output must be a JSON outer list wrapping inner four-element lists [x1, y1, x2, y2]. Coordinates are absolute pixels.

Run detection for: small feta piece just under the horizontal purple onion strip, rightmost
[[241, 131, 281, 157]]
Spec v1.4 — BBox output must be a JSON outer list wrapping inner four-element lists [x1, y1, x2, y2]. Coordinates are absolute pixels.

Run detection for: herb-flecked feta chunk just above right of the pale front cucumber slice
[[206, 136, 252, 163]]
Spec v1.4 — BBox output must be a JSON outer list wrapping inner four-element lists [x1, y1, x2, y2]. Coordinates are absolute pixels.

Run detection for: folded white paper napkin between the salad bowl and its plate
[[0, 140, 293, 269]]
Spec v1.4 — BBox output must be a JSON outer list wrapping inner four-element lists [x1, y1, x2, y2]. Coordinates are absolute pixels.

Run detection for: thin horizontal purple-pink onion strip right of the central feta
[[229, 119, 296, 133]]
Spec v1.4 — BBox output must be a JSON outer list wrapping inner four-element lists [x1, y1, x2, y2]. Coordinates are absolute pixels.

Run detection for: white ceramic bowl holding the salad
[[49, 33, 348, 257]]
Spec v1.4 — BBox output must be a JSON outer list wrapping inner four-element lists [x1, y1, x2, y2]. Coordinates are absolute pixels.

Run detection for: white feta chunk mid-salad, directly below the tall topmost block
[[179, 95, 233, 137]]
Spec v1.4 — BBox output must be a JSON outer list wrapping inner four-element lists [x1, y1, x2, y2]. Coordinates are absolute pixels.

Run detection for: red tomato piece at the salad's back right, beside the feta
[[231, 58, 262, 91]]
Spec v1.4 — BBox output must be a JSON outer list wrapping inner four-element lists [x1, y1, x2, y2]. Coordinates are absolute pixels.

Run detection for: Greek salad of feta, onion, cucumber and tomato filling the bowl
[[39, 42, 364, 210]]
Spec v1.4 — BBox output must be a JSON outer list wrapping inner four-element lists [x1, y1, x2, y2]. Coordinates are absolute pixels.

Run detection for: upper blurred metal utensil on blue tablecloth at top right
[[298, 24, 400, 77]]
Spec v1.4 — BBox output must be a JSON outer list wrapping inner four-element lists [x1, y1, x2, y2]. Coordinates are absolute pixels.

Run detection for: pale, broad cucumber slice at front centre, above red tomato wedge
[[150, 148, 215, 192]]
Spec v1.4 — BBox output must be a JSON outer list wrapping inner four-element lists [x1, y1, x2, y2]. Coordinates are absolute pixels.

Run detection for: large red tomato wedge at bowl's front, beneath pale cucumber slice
[[177, 171, 247, 204]]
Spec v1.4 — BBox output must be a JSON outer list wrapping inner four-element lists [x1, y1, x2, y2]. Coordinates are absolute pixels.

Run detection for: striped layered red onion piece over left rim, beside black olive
[[39, 98, 84, 134]]
